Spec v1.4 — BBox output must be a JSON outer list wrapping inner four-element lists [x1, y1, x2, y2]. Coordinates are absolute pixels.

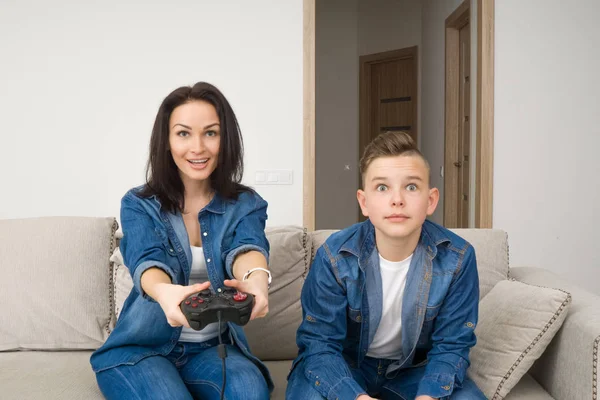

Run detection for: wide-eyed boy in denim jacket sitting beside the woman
[[286, 132, 485, 400]]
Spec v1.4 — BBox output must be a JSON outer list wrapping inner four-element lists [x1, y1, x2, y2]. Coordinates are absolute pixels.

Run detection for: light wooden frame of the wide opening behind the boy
[[302, 0, 495, 230]]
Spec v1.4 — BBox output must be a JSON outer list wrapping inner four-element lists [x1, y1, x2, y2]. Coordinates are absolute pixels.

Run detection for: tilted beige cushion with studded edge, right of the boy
[[468, 280, 571, 400]]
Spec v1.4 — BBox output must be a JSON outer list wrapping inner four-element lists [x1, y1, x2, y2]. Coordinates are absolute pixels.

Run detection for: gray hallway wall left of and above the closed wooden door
[[315, 0, 421, 229]]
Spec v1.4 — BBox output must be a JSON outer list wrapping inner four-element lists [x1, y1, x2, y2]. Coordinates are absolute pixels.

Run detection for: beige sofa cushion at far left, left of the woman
[[0, 217, 117, 350]]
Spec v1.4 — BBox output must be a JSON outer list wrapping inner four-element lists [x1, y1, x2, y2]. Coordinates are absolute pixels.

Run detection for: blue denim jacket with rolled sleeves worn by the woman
[[91, 188, 273, 389]]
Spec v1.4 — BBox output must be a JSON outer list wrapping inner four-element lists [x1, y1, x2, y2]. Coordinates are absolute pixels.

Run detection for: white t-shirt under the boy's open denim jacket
[[367, 254, 413, 360]]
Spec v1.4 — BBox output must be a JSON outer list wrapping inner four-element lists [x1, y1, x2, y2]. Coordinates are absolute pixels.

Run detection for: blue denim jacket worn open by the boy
[[292, 220, 479, 400]]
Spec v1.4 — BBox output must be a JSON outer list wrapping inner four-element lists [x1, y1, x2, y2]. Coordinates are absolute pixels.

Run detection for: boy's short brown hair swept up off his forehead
[[359, 131, 430, 186]]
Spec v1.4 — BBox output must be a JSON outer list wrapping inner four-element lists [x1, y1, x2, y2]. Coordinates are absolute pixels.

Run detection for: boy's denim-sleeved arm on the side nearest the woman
[[296, 244, 365, 400]]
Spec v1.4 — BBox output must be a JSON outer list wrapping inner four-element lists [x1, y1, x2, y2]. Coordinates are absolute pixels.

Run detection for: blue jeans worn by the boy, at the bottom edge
[[285, 357, 486, 400]]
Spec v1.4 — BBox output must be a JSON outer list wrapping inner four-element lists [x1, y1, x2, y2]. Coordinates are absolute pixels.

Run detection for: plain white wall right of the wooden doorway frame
[[494, 0, 600, 294]]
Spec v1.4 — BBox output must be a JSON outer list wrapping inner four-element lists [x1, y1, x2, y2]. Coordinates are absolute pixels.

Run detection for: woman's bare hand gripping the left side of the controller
[[153, 281, 210, 328]]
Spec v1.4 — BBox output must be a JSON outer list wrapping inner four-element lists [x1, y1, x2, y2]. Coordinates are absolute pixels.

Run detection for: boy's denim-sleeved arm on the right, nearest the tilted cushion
[[417, 245, 479, 399]]
